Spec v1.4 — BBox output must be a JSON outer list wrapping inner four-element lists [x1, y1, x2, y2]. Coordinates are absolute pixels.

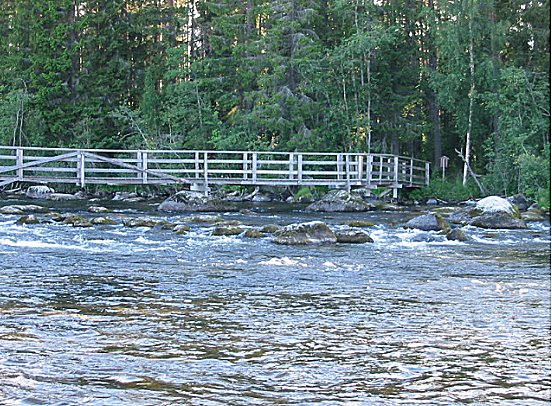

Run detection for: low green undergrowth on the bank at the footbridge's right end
[[409, 178, 479, 202]]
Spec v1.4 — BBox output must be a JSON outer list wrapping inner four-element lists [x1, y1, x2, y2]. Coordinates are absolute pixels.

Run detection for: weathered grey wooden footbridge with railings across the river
[[0, 146, 429, 197]]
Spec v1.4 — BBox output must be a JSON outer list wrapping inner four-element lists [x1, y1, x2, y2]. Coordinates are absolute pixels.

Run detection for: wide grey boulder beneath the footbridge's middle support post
[[158, 190, 238, 212]]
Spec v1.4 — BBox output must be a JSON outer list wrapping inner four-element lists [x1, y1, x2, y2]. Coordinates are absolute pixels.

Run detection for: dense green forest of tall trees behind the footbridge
[[0, 0, 550, 202]]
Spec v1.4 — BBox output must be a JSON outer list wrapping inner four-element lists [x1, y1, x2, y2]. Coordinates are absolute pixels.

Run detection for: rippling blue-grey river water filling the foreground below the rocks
[[0, 201, 550, 405]]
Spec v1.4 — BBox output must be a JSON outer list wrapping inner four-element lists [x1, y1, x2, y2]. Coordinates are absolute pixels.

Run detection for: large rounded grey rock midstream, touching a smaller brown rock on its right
[[274, 221, 337, 245]]
